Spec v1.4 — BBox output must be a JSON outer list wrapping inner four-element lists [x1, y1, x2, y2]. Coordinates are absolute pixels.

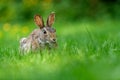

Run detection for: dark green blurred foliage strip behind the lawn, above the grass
[[0, 0, 120, 23]]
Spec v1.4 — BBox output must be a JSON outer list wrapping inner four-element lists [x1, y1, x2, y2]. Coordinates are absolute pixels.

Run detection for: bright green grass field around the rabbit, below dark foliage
[[0, 20, 120, 80]]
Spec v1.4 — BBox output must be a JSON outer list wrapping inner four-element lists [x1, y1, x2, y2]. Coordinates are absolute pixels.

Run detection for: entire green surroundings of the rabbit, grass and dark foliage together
[[0, 0, 120, 80]]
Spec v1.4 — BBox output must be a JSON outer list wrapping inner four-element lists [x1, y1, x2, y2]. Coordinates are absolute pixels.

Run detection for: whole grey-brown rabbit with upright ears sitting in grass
[[20, 12, 57, 53]]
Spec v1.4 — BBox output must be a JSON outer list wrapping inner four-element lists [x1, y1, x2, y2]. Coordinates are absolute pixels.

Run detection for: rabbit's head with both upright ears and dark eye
[[34, 12, 56, 43]]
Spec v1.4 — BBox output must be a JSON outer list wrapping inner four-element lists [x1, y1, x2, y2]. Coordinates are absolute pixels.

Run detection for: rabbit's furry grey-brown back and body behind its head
[[20, 29, 44, 52]]
